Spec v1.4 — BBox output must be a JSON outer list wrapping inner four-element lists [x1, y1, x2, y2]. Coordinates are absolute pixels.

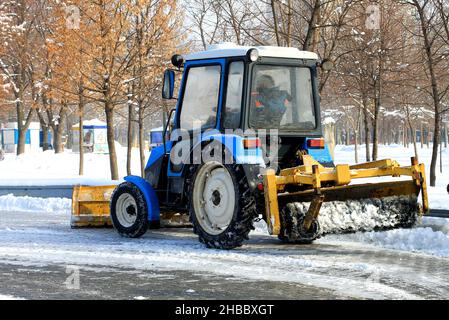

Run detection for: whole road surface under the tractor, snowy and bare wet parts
[[0, 212, 449, 299]]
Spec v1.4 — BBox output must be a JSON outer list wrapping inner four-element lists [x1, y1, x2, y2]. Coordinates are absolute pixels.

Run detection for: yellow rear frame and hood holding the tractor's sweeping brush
[[264, 155, 429, 235]]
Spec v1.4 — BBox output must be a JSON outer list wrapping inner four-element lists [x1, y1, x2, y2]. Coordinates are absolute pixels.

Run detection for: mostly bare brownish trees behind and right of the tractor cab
[[183, 0, 449, 185]]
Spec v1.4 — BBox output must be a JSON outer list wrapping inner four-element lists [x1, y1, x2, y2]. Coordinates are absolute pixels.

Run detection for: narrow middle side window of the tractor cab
[[223, 61, 244, 129]]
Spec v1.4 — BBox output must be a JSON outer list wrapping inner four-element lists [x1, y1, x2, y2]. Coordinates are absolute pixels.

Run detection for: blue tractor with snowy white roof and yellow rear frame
[[110, 44, 425, 249]]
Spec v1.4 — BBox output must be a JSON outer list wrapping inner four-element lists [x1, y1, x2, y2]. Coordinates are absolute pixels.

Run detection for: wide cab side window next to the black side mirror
[[180, 65, 221, 130]]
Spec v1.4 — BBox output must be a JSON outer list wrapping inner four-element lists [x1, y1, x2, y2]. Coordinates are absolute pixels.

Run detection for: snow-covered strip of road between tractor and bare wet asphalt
[[0, 212, 449, 299]]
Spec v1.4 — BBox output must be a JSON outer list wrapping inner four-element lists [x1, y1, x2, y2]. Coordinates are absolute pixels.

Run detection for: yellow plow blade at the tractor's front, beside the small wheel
[[70, 186, 116, 228]]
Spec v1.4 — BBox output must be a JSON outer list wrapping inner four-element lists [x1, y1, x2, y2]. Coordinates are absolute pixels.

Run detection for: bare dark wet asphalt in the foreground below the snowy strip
[[0, 261, 344, 300]]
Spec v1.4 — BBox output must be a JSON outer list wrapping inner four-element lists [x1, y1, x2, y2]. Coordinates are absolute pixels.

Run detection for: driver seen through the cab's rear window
[[253, 75, 292, 128]]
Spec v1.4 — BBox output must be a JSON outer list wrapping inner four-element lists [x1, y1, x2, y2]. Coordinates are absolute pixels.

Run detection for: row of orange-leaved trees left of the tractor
[[0, 0, 180, 180]]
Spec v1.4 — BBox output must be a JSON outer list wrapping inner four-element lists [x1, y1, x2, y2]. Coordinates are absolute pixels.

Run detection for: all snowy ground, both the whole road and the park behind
[[0, 146, 449, 299]]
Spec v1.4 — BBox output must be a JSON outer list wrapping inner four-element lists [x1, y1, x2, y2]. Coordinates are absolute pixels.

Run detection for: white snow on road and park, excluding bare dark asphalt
[[0, 146, 449, 299]]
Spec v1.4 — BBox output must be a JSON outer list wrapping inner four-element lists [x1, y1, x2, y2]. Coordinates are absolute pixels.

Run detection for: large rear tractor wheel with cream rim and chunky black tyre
[[189, 161, 257, 250]]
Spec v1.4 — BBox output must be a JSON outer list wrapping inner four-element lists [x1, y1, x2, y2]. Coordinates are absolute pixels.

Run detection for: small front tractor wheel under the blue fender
[[111, 182, 148, 238]]
